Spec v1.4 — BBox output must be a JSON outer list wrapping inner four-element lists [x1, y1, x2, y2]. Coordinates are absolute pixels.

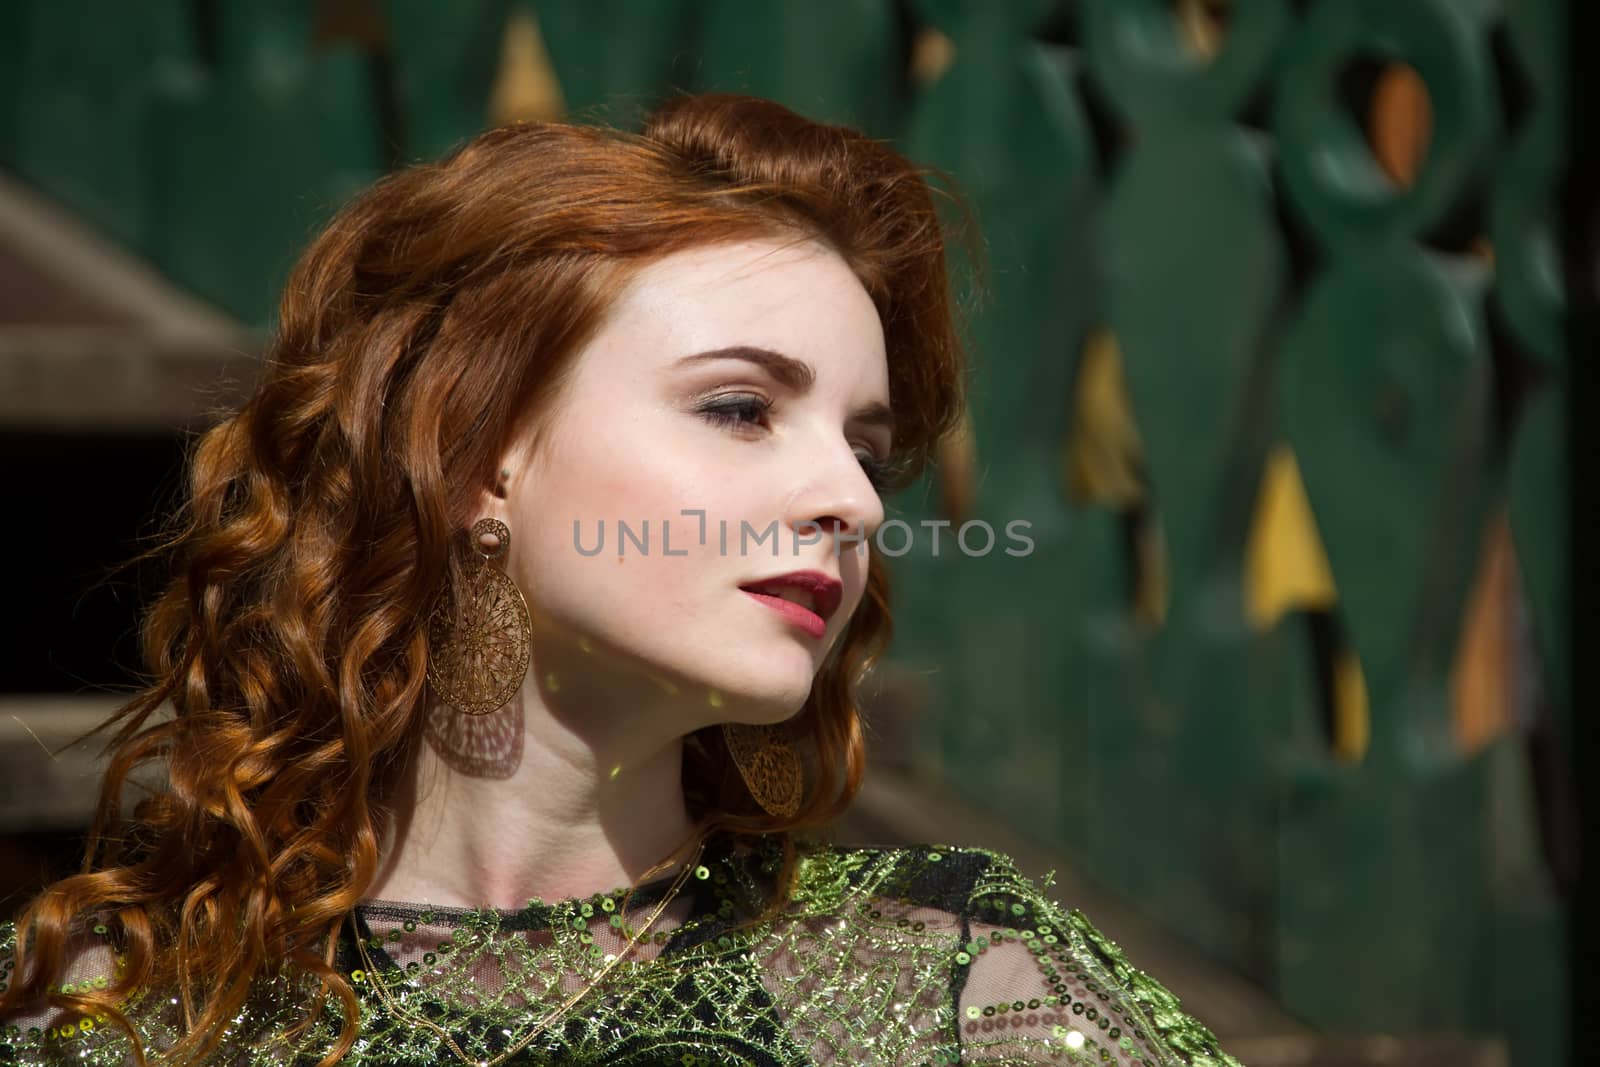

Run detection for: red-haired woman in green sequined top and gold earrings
[[0, 96, 1234, 1064]]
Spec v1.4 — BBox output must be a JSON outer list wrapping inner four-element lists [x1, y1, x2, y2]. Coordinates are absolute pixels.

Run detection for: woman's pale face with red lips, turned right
[[504, 242, 891, 729]]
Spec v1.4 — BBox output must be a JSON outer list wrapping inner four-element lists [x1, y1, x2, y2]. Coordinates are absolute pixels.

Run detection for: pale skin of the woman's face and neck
[[368, 240, 891, 909]]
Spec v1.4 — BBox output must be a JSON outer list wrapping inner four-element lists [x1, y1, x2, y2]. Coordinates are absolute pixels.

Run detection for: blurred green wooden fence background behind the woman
[[0, 0, 1578, 1067]]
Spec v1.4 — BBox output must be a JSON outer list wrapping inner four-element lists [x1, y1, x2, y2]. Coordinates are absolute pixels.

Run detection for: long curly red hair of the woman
[[0, 96, 963, 1064]]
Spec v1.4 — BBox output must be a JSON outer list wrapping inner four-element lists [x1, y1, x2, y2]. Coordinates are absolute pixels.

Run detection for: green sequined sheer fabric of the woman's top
[[0, 840, 1238, 1067]]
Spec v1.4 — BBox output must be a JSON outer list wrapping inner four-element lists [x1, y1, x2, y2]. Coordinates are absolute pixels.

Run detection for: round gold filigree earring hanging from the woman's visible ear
[[427, 518, 533, 715]]
